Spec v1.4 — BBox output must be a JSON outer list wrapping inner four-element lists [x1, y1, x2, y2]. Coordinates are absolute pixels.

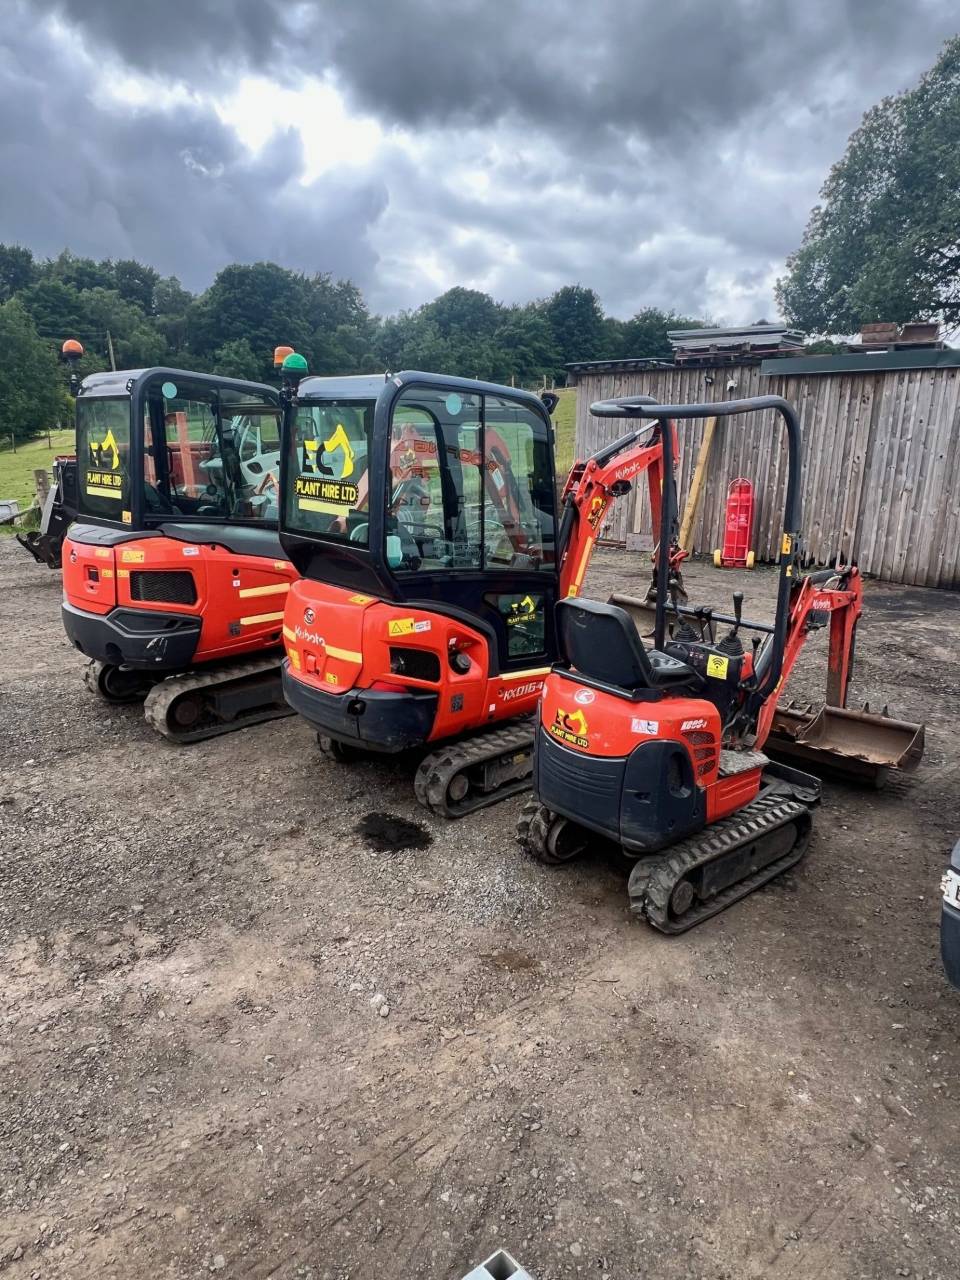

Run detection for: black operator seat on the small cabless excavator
[[557, 599, 703, 691]]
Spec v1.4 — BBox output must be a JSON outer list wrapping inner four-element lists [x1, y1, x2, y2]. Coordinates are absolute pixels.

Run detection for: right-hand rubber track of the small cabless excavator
[[628, 794, 813, 933]]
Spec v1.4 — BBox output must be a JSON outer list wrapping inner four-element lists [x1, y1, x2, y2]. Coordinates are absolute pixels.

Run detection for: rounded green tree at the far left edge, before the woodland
[[0, 298, 63, 440]]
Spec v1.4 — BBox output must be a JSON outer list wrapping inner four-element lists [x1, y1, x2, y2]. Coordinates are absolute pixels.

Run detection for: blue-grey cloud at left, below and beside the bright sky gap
[[0, 10, 387, 288]]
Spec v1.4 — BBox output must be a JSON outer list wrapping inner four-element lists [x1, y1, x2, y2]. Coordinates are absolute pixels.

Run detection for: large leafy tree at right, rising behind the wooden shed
[[777, 36, 960, 333]]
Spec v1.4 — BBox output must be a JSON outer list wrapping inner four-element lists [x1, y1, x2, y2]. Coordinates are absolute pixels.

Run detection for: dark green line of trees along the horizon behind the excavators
[[0, 244, 705, 439]]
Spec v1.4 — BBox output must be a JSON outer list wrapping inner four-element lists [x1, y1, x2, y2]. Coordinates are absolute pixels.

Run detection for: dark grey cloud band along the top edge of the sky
[[35, 0, 957, 142]]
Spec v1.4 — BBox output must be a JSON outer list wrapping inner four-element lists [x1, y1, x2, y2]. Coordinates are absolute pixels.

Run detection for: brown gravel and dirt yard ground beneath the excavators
[[0, 541, 960, 1280]]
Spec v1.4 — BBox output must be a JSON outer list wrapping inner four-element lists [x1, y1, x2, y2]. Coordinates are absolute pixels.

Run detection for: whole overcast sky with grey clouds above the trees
[[0, 0, 960, 324]]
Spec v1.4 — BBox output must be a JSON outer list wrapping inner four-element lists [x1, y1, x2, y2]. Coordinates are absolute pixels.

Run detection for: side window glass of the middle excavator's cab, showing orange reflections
[[387, 387, 554, 571]]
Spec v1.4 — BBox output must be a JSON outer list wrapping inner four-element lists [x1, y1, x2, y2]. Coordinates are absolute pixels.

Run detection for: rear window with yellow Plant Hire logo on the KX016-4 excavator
[[284, 401, 374, 547]]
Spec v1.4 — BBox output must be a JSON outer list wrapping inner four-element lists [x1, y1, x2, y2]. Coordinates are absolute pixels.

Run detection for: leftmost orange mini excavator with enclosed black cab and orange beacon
[[63, 360, 297, 742]]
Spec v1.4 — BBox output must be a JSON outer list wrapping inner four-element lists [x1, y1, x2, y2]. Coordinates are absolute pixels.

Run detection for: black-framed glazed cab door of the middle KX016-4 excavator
[[385, 383, 558, 672]]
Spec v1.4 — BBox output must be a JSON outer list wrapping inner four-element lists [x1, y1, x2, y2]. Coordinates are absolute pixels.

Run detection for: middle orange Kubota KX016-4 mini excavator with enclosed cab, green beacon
[[273, 371, 682, 817]]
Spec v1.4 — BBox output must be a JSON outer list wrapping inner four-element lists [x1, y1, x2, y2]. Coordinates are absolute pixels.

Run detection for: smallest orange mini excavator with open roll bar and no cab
[[518, 396, 923, 933]]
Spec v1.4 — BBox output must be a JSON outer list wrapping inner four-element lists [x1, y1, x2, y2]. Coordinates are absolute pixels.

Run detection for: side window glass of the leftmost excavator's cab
[[143, 381, 280, 525]]
